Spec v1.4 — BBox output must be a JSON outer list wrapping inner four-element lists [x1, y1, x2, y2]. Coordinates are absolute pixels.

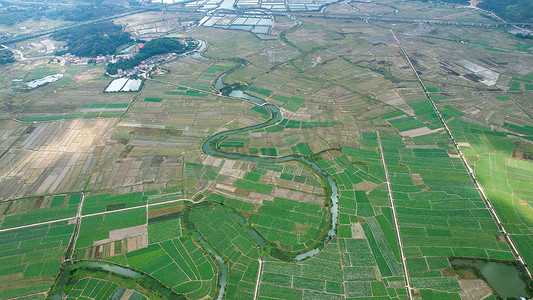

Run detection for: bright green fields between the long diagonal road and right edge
[[444, 122, 533, 263]]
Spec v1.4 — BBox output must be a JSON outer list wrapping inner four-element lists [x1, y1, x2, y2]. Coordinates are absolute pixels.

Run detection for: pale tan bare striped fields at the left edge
[[0, 119, 113, 199]]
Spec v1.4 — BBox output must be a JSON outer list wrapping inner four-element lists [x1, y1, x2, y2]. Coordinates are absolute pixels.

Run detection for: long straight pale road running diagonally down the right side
[[390, 29, 532, 278]]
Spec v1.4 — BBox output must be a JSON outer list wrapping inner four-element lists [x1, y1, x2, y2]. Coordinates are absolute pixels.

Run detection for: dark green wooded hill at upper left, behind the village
[[52, 21, 133, 57]]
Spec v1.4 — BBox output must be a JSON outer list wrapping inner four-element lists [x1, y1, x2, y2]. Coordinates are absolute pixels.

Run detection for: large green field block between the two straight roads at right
[[381, 135, 513, 292]]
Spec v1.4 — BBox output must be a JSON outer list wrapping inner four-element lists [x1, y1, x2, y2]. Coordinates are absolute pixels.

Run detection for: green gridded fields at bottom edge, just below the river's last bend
[[259, 238, 405, 299]]
